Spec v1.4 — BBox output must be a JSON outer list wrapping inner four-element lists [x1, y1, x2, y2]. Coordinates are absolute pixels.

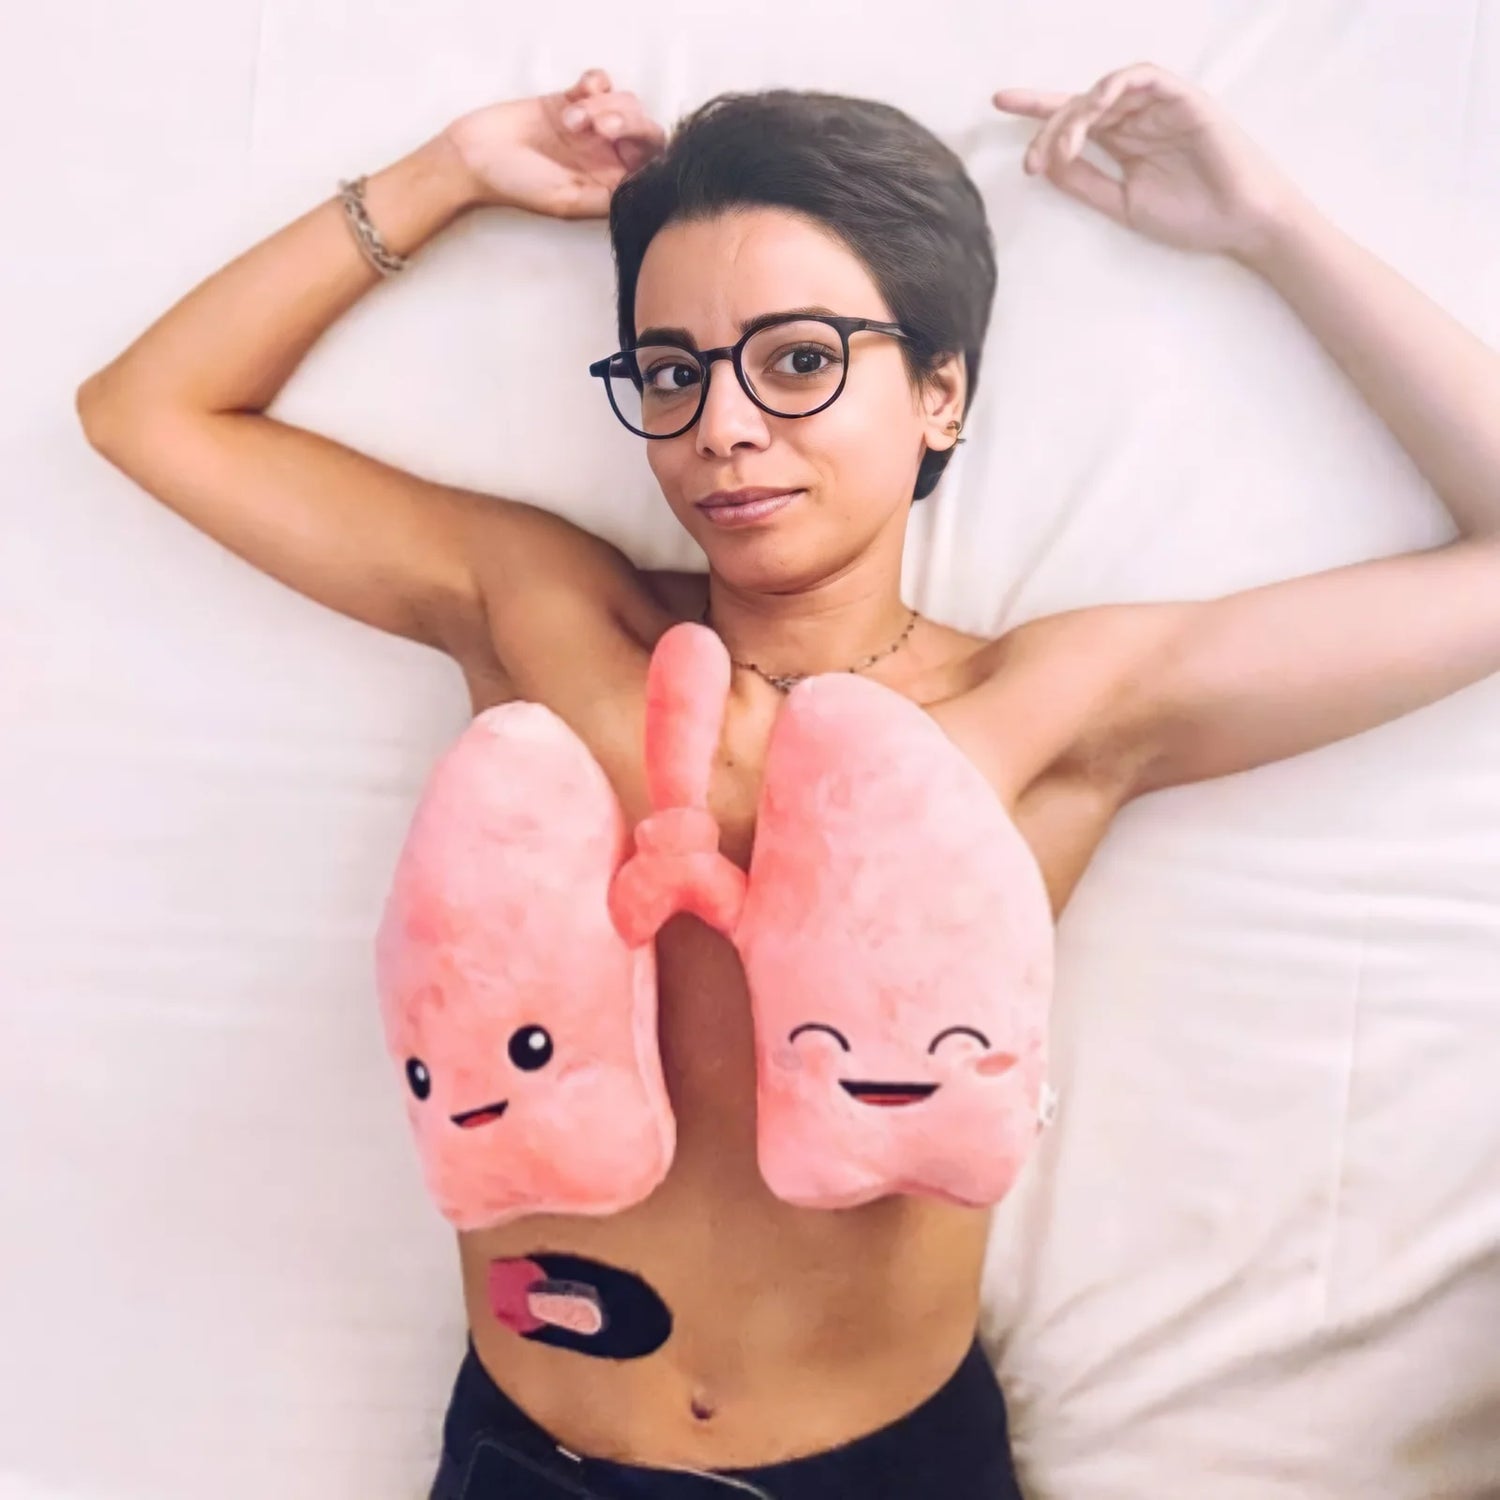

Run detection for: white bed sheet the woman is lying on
[[0, 0, 1500, 1500]]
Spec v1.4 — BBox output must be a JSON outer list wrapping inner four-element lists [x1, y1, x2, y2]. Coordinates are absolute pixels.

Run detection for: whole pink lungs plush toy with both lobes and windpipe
[[377, 624, 1053, 1229]]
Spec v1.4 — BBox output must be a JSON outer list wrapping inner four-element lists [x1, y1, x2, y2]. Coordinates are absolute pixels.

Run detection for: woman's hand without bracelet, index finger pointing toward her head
[[993, 63, 1293, 257]]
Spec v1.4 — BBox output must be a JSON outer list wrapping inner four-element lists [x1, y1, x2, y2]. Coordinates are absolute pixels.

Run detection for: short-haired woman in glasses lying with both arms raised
[[80, 55, 1500, 1500]]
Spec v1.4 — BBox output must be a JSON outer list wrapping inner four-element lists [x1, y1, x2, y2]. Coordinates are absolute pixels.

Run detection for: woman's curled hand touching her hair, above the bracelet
[[444, 68, 666, 219]]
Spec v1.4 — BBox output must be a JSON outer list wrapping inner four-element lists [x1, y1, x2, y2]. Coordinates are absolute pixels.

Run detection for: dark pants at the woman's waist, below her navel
[[432, 1341, 1020, 1500]]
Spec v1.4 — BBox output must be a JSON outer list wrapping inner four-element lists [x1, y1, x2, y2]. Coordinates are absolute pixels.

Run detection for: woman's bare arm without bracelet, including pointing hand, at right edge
[[996, 63, 1500, 797]]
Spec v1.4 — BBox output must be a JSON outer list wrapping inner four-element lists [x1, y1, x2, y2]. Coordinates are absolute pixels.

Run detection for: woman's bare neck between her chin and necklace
[[708, 573, 912, 677]]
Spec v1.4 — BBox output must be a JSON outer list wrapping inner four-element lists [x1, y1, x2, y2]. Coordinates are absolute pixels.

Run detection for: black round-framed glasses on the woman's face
[[588, 314, 911, 438]]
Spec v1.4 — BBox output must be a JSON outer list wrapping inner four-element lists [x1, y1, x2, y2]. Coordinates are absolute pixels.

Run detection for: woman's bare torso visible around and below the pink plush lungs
[[461, 575, 1115, 1467]]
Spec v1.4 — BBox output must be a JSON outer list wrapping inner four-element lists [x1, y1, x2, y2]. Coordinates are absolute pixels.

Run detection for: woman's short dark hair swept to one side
[[609, 89, 995, 500]]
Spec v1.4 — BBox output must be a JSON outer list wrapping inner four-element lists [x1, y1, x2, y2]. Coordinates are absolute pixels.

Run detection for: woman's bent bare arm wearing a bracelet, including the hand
[[78, 74, 666, 654]]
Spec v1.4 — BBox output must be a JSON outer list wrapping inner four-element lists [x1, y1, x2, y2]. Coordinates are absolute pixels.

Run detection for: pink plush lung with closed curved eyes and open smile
[[734, 674, 1053, 1208]]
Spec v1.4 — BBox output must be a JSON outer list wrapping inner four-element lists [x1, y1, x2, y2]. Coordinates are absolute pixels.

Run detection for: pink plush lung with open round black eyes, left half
[[375, 704, 675, 1230]]
